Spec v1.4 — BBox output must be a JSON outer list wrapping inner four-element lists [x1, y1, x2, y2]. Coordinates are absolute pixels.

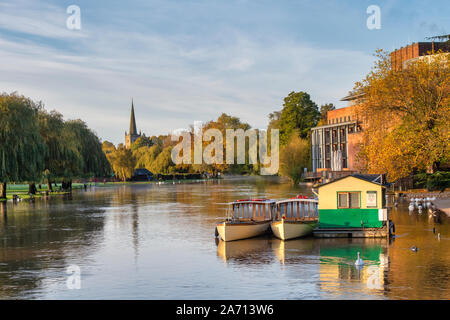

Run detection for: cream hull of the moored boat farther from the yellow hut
[[217, 221, 270, 241]]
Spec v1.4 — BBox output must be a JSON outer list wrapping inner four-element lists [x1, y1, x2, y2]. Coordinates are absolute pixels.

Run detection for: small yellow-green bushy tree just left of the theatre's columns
[[280, 133, 311, 185]]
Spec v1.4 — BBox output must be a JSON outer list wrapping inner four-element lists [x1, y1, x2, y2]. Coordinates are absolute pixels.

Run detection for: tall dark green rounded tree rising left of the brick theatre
[[279, 91, 320, 145]]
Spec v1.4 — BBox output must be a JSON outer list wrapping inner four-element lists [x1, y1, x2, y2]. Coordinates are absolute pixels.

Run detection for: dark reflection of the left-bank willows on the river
[[0, 191, 108, 299]]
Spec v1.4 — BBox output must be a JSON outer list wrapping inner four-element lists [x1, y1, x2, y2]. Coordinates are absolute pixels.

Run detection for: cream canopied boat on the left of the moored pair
[[216, 199, 276, 241]]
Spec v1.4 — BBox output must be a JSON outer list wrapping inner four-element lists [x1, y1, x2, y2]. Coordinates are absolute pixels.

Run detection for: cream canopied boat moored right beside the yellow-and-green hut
[[270, 196, 319, 240]]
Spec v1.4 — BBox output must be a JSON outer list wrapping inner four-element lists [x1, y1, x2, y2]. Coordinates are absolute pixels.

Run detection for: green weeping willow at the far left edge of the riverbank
[[0, 93, 46, 199]]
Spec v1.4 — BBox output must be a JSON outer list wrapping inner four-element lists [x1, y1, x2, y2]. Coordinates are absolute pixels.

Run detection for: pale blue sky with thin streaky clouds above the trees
[[0, 0, 450, 144]]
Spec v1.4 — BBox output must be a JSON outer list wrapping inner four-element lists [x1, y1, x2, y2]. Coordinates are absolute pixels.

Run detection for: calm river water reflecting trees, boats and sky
[[0, 177, 450, 299]]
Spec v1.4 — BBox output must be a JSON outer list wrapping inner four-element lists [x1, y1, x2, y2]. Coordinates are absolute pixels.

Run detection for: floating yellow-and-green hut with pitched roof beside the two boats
[[314, 174, 394, 238]]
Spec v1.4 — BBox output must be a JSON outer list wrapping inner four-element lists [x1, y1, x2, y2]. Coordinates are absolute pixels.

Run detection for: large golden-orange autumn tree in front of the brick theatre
[[355, 51, 450, 180]]
